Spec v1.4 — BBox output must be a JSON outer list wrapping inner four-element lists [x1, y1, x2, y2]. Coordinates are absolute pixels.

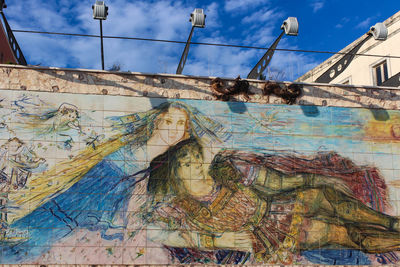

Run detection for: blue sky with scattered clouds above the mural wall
[[5, 0, 400, 80]]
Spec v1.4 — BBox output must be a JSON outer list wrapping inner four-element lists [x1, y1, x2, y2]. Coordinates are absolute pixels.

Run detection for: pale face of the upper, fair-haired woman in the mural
[[158, 107, 188, 146]]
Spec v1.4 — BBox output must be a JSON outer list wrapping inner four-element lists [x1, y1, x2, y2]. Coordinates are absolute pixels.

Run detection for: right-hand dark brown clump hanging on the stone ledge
[[263, 81, 303, 105]]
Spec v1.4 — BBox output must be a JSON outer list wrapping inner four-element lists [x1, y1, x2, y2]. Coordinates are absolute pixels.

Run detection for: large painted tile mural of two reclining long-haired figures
[[0, 91, 400, 265]]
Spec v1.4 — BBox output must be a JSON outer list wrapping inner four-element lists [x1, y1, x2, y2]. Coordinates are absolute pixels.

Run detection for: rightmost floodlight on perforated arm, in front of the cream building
[[315, 22, 388, 83]]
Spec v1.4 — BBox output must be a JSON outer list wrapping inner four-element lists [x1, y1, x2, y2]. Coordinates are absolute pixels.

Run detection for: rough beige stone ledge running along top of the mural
[[0, 64, 400, 110]]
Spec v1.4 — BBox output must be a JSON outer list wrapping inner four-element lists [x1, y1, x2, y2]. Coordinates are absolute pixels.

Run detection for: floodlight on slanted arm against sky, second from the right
[[247, 17, 299, 79]]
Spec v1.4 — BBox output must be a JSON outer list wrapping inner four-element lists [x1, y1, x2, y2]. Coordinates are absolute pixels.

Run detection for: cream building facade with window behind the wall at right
[[297, 12, 400, 87]]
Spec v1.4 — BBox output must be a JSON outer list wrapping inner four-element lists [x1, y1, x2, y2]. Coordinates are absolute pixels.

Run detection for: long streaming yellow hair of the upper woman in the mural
[[12, 102, 231, 224]]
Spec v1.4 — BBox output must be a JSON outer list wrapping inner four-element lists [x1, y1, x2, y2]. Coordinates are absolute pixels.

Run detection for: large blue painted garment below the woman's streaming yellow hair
[[0, 160, 135, 264]]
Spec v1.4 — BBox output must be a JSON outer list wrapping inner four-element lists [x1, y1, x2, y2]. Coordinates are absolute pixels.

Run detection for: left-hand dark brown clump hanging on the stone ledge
[[211, 76, 254, 101]]
